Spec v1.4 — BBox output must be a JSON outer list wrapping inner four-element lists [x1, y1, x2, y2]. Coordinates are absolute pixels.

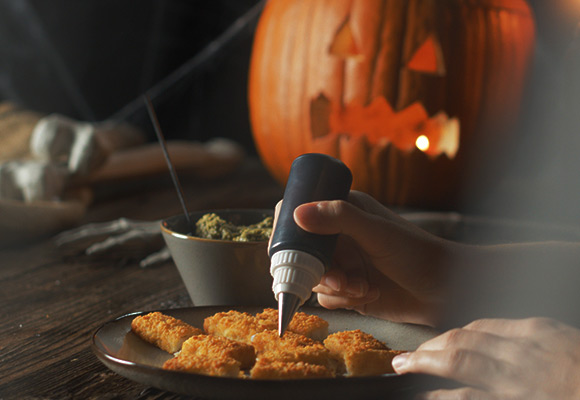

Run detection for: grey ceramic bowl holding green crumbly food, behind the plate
[[161, 209, 276, 306]]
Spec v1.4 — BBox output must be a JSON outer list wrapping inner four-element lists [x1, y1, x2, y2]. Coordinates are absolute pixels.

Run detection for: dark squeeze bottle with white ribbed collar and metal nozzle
[[269, 153, 352, 336]]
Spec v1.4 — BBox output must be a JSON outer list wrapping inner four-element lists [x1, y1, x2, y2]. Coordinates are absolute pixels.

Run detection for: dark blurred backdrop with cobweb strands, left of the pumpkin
[[0, 0, 260, 149]]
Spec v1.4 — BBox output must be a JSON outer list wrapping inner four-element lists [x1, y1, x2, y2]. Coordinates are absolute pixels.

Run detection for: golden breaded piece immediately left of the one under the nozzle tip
[[179, 335, 256, 369]]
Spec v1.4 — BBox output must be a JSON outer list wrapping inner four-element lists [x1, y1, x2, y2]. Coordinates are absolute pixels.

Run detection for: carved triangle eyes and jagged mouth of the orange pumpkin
[[311, 18, 459, 158]]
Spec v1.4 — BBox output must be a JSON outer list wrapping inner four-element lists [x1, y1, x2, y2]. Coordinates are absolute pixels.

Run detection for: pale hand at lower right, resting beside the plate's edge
[[393, 318, 580, 400]]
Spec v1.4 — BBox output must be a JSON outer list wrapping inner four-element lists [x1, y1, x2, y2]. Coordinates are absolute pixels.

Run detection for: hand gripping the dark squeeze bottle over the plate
[[294, 191, 455, 325]]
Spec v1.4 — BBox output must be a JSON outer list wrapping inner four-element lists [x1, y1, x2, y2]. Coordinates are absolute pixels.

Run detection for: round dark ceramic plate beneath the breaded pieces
[[92, 306, 446, 400]]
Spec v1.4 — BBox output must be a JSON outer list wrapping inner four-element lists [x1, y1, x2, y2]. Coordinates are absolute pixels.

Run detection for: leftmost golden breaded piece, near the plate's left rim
[[131, 312, 203, 353]]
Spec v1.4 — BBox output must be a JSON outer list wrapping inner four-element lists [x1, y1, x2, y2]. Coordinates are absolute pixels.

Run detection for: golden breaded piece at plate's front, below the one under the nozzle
[[250, 358, 335, 379]]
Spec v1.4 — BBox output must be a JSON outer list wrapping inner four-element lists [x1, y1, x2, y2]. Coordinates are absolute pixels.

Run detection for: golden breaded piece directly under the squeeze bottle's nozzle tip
[[252, 330, 334, 368]]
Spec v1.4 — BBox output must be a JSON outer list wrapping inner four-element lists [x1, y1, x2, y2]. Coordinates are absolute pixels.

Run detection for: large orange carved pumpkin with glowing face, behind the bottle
[[249, 0, 535, 207]]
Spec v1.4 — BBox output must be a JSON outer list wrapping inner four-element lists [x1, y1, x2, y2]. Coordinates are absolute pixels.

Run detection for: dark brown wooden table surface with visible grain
[[0, 157, 283, 400]]
